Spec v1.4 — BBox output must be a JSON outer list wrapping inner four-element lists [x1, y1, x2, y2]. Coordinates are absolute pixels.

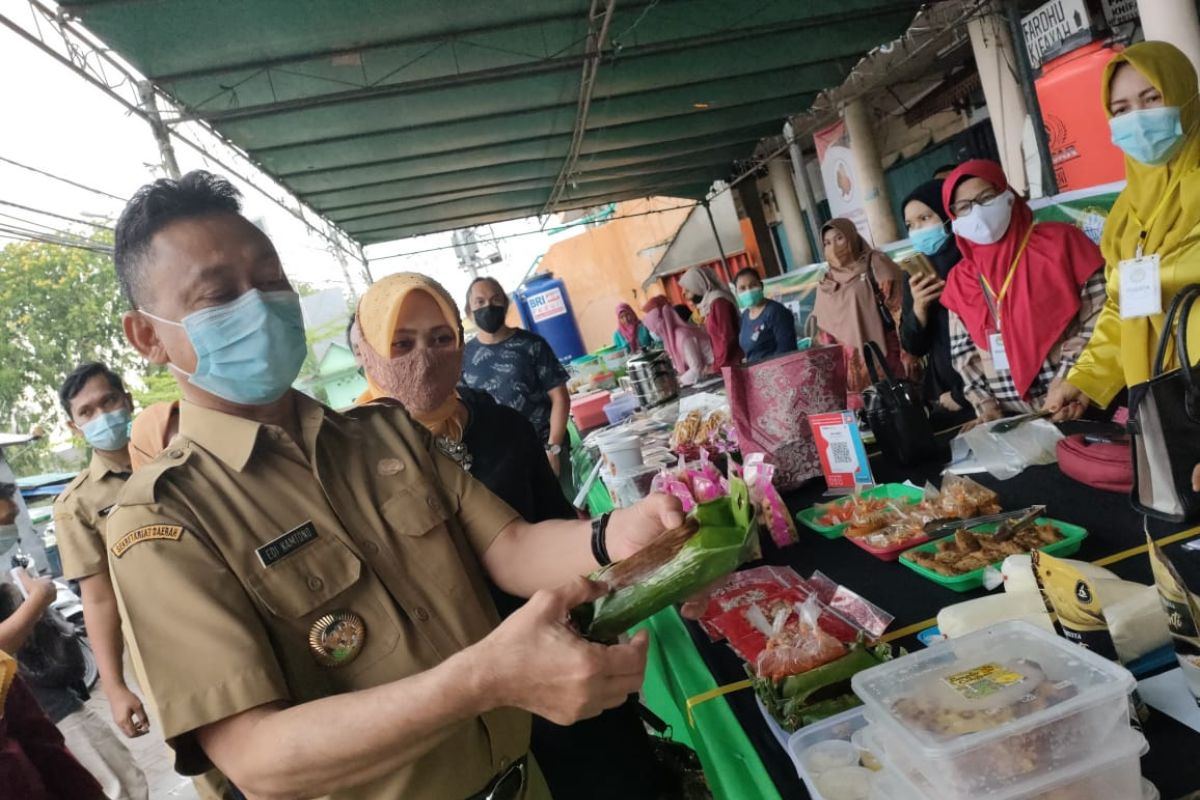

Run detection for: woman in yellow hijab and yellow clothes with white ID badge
[[1046, 42, 1200, 419]]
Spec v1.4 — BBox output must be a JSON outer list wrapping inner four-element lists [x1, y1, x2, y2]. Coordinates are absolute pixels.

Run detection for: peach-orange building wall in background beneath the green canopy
[[538, 197, 688, 351]]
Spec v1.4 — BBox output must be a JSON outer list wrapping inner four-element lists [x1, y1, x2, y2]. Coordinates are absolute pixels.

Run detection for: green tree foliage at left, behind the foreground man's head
[[0, 234, 140, 441]]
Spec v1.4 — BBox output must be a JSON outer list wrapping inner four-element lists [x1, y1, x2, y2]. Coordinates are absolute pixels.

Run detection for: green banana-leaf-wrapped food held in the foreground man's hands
[[571, 479, 757, 642]]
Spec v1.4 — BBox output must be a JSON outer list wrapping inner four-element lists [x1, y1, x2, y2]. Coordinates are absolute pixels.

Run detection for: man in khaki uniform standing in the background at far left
[[54, 363, 150, 798]]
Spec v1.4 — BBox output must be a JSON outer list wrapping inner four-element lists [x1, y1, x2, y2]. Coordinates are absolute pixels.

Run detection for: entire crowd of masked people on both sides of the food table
[[7, 42, 1200, 800]]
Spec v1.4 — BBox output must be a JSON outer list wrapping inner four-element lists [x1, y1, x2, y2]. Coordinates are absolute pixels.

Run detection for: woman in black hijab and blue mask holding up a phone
[[900, 180, 973, 416]]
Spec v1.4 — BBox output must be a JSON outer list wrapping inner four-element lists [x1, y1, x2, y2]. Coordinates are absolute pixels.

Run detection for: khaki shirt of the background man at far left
[[54, 451, 130, 581]]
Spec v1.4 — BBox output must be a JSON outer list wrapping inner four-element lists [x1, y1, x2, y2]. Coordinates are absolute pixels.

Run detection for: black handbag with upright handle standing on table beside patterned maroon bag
[[863, 341, 946, 467]]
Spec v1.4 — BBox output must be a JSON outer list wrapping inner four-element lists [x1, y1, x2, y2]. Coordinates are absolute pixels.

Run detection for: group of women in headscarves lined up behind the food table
[[618, 42, 1200, 438]]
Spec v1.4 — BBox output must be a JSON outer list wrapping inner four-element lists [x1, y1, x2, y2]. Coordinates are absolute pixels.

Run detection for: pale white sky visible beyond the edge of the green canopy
[[0, 0, 576, 311]]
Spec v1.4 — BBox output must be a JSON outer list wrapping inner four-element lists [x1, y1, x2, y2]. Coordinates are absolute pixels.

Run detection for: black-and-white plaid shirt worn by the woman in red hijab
[[950, 270, 1105, 414]]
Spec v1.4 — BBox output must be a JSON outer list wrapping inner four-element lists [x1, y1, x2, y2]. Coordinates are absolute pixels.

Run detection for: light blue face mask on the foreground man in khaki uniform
[[142, 289, 308, 405]]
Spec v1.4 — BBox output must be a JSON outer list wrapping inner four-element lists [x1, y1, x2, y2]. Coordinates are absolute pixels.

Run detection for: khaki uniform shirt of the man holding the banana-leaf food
[[108, 393, 546, 800]]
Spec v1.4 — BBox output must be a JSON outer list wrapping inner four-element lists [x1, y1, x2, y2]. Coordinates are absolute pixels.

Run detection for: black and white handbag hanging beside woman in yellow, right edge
[[1129, 283, 1200, 522]]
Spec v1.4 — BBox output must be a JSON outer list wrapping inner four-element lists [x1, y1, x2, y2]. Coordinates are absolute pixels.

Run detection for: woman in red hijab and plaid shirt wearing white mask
[[941, 160, 1104, 422]]
